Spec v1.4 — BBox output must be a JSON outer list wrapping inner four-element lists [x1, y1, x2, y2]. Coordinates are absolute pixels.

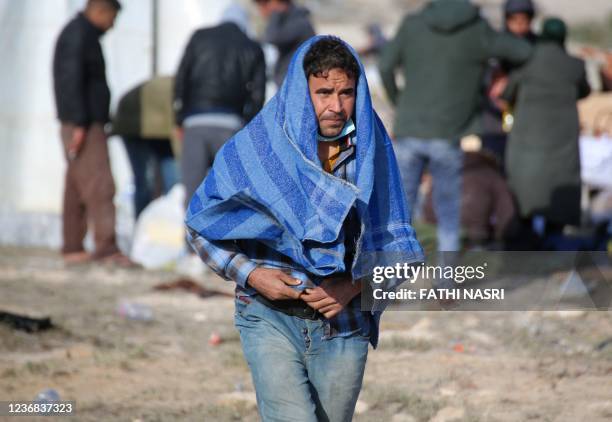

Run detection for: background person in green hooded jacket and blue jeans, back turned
[[379, 0, 531, 251]]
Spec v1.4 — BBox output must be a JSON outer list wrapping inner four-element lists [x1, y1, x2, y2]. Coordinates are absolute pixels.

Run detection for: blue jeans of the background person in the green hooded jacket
[[393, 138, 463, 252]]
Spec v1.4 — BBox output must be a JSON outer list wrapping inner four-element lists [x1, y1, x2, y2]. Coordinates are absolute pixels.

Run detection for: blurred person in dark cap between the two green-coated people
[[479, 0, 537, 163]]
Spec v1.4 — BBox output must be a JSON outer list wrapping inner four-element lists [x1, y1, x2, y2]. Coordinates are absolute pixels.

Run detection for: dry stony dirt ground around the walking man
[[0, 248, 612, 422]]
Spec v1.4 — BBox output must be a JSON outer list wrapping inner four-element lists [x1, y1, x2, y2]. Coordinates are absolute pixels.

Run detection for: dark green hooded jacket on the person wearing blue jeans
[[379, 0, 532, 141]]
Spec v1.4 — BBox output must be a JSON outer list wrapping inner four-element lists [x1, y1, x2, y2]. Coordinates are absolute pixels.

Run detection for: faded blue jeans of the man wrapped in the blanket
[[234, 297, 369, 422]]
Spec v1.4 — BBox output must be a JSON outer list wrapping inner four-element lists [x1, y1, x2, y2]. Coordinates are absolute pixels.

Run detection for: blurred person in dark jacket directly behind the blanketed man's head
[[255, 0, 315, 88]]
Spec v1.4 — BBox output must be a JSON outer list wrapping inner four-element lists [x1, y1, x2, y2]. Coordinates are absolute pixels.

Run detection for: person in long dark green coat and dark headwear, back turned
[[502, 18, 590, 247]]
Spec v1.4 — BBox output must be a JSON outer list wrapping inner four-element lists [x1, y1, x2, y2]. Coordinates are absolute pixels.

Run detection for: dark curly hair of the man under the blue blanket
[[304, 37, 360, 79]]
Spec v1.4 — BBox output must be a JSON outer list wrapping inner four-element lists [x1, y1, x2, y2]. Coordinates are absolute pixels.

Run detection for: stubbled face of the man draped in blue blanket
[[308, 69, 355, 137]]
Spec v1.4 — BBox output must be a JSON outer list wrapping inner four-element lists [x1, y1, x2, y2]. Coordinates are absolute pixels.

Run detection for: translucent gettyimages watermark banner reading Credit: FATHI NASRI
[[361, 251, 612, 311]]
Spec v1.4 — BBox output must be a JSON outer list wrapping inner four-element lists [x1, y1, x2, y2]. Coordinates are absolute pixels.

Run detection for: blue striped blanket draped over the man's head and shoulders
[[186, 37, 423, 279]]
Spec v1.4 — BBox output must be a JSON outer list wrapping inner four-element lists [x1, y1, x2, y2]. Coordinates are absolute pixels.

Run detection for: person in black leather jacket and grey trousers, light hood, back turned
[[174, 4, 266, 274]]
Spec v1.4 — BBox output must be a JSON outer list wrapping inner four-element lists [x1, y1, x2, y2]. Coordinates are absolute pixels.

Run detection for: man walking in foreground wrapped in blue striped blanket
[[186, 36, 423, 421]]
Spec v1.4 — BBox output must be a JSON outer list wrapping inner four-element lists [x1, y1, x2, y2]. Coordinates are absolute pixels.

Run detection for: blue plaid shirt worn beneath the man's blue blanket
[[189, 136, 378, 346]]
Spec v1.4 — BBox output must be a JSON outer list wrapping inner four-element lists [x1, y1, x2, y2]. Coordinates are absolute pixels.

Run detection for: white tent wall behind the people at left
[[0, 0, 230, 247]]
